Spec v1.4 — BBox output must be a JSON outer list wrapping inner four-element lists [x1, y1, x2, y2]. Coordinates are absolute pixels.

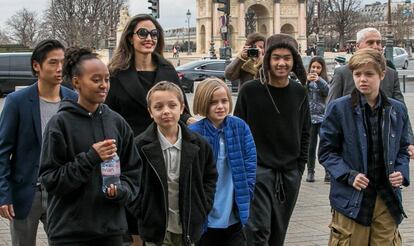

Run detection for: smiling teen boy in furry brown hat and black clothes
[[234, 34, 310, 246]]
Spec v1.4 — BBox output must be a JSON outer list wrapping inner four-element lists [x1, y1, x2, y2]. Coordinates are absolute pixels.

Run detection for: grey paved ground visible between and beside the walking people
[[0, 93, 414, 246]]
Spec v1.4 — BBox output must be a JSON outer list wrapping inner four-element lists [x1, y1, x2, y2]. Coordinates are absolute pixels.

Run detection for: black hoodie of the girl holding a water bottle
[[40, 101, 142, 243]]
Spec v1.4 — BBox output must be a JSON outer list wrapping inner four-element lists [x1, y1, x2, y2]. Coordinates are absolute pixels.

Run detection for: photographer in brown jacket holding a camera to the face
[[225, 33, 266, 87]]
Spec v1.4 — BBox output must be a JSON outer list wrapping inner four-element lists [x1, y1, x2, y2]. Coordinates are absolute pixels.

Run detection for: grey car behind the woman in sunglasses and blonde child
[[176, 59, 238, 92]]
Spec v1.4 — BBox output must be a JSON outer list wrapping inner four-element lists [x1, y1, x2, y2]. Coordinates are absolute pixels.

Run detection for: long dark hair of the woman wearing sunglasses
[[108, 14, 164, 74]]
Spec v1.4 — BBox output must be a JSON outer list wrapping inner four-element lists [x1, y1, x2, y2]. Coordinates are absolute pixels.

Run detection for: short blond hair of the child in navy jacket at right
[[348, 48, 387, 76]]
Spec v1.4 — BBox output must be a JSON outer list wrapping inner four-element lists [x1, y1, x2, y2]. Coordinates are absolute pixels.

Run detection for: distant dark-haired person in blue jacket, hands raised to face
[[306, 56, 329, 182]]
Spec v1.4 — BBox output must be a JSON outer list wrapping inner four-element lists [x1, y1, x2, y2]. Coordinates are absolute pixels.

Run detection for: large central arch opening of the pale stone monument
[[245, 4, 271, 36]]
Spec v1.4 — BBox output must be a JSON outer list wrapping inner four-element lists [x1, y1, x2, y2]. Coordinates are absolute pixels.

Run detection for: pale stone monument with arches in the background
[[196, 0, 306, 54]]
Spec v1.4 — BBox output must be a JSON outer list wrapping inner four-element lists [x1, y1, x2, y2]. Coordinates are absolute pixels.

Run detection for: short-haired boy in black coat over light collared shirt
[[129, 81, 217, 246]]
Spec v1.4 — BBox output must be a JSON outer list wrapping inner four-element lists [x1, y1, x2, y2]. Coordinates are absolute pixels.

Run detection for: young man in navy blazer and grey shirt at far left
[[0, 39, 77, 246]]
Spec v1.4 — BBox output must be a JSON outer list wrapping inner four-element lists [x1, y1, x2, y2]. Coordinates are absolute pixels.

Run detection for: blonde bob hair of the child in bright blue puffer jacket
[[193, 78, 233, 117]]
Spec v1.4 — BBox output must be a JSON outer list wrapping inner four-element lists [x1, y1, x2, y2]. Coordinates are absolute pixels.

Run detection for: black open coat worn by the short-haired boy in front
[[130, 123, 217, 245]]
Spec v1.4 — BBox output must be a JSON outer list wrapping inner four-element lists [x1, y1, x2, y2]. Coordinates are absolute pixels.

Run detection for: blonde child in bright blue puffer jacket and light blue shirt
[[189, 78, 256, 246]]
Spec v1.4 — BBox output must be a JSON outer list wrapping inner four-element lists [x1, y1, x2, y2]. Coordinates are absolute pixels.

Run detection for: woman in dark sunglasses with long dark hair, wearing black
[[106, 14, 195, 245]]
